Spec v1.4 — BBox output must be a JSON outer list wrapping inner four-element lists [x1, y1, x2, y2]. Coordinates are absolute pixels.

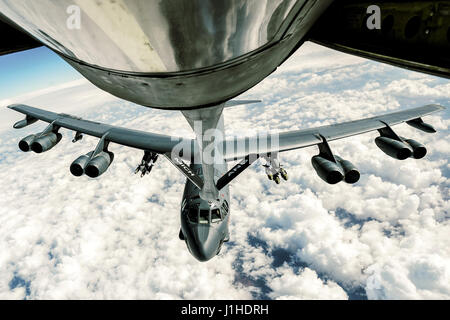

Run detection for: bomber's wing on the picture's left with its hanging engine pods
[[8, 104, 203, 187]]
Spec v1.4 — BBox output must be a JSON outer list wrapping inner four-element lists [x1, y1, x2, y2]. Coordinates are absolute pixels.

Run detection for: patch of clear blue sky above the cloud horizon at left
[[0, 47, 82, 99]]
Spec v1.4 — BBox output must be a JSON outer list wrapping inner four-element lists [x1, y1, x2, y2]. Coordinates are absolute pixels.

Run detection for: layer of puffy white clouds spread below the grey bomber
[[0, 44, 450, 299]]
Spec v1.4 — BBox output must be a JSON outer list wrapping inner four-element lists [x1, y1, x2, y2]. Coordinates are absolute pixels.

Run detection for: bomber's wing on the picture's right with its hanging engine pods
[[217, 104, 445, 190]]
